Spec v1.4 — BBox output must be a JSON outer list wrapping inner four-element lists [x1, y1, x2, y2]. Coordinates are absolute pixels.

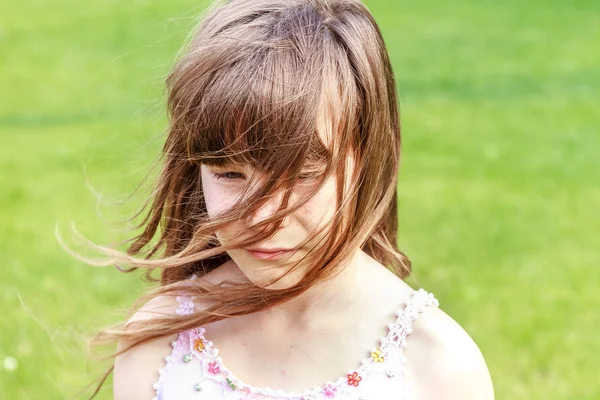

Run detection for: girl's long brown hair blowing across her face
[[77, 0, 410, 397]]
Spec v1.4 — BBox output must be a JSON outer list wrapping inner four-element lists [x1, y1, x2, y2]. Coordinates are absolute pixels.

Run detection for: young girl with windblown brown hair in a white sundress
[[86, 0, 493, 400]]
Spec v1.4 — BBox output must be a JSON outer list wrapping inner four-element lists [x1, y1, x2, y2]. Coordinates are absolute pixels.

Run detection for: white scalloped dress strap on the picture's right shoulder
[[382, 289, 440, 350]]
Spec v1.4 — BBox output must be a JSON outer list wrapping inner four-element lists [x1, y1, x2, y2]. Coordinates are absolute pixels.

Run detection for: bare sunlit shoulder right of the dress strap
[[405, 307, 494, 400]]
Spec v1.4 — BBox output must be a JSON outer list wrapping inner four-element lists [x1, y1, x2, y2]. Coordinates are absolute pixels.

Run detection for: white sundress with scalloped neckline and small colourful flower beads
[[154, 289, 439, 400]]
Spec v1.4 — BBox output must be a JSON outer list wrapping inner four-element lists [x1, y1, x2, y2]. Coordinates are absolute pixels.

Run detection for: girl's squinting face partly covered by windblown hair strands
[[201, 157, 353, 288]]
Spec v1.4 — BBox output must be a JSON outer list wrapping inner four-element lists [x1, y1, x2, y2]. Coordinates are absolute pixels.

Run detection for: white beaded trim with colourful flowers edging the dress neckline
[[153, 289, 439, 400]]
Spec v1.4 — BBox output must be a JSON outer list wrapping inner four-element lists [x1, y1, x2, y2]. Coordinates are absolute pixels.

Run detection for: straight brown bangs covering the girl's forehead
[[188, 43, 331, 171]]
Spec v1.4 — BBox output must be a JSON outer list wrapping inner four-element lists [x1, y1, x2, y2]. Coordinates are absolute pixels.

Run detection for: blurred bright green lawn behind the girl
[[0, 0, 600, 400]]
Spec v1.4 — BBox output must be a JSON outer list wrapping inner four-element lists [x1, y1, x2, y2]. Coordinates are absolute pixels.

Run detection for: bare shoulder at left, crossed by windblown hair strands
[[113, 296, 177, 400]]
